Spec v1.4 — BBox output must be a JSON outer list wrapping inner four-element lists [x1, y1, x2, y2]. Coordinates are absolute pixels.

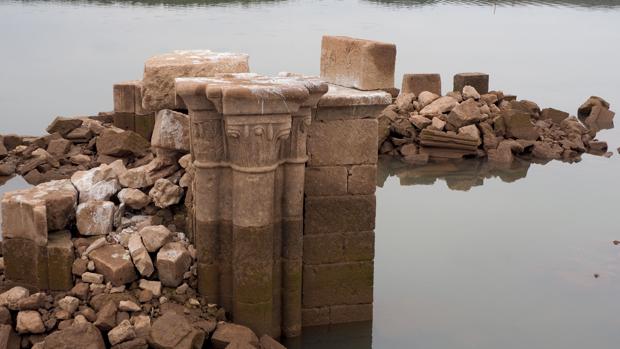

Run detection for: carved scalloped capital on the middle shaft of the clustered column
[[224, 114, 291, 172]]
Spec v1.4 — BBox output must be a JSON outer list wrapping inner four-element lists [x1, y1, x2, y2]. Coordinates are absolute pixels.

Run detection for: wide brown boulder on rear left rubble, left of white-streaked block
[[97, 130, 151, 157]]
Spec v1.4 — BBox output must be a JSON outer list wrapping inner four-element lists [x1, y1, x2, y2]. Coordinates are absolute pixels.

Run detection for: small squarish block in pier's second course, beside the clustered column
[[304, 166, 348, 196]]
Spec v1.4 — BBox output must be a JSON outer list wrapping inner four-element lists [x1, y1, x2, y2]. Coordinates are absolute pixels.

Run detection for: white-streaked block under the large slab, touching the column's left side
[[151, 109, 189, 153]]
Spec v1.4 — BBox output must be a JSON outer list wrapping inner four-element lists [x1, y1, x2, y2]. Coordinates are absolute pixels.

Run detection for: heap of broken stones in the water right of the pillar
[[379, 74, 614, 165]]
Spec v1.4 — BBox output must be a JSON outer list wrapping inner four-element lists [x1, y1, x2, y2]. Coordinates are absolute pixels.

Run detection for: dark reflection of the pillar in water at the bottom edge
[[284, 321, 372, 349]]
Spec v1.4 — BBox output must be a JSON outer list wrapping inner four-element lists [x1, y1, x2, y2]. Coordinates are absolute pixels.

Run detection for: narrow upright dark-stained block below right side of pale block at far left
[[47, 231, 75, 291]]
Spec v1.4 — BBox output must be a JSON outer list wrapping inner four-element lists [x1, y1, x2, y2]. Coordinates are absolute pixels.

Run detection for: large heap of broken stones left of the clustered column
[[0, 109, 283, 349]]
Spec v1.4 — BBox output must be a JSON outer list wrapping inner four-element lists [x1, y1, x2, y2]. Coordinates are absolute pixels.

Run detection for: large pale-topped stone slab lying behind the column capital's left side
[[142, 50, 249, 111]]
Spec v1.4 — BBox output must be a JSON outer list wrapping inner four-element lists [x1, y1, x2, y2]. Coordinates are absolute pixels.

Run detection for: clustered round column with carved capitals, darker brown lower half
[[176, 74, 326, 337]]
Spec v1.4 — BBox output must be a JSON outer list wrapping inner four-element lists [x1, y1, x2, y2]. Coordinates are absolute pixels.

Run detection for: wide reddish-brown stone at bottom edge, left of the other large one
[[43, 323, 105, 349]]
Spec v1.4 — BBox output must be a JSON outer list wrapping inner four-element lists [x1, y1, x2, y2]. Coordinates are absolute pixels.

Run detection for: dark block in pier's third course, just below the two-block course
[[304, 195, 376, 235]]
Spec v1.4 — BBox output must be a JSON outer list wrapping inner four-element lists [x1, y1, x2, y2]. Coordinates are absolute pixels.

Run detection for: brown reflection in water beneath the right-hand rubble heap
[[377, 156, 531, 191]]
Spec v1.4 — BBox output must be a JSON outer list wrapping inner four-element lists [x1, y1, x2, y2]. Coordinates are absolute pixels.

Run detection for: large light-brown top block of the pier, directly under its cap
[[307, 119, 378, 166]]
